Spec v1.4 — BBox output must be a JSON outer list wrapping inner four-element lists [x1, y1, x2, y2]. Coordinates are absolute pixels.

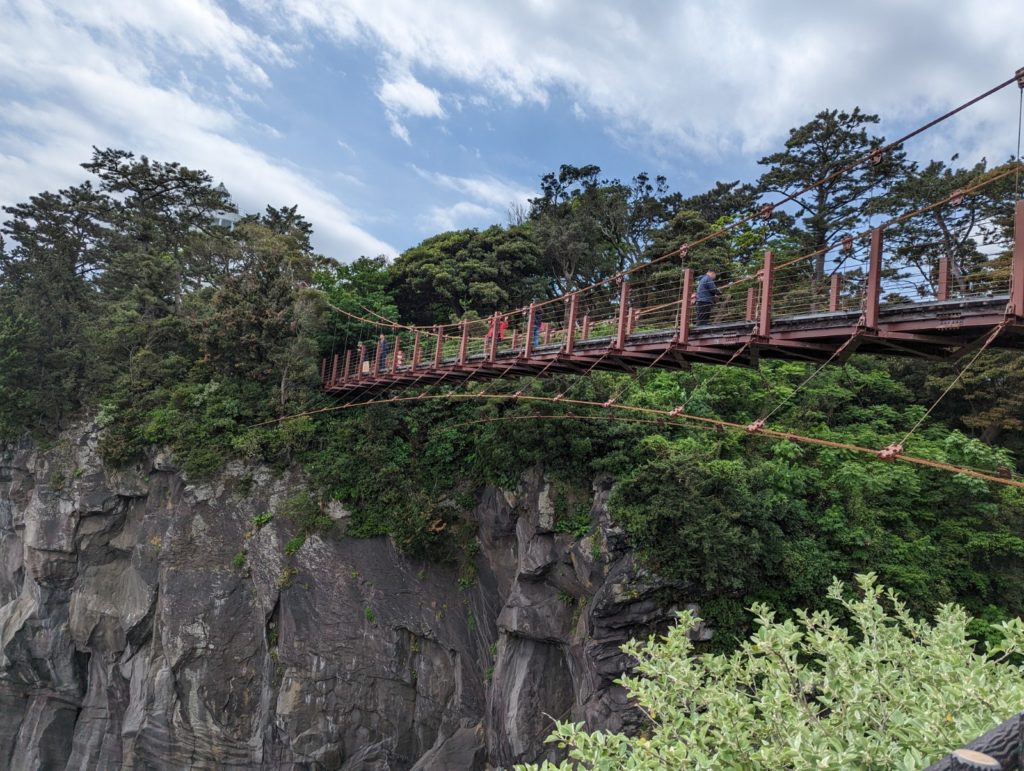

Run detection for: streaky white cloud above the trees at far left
[[0, 0, 396, 260]]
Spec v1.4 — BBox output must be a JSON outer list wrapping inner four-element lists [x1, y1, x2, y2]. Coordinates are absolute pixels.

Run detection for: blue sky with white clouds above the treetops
[[0, 0, 1024, 261]]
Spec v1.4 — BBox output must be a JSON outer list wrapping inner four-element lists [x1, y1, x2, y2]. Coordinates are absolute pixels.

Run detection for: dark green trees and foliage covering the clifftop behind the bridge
[[6, 105, 1024, 648]]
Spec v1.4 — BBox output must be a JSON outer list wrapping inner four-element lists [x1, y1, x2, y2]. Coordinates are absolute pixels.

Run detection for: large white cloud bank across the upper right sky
[[262, 0, 1024, 158]]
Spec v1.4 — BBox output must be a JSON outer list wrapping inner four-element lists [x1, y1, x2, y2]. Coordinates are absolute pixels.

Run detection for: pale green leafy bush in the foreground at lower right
[[519, 574, 1024, 771]]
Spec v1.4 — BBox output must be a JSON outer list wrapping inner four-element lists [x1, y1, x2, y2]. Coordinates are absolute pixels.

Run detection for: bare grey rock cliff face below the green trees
[[0, 426, 696, 769]]
